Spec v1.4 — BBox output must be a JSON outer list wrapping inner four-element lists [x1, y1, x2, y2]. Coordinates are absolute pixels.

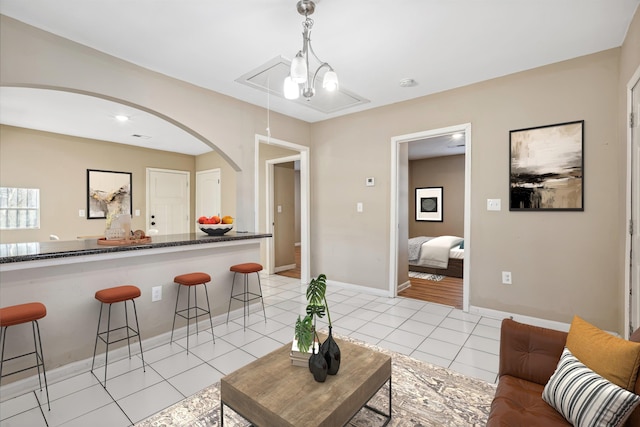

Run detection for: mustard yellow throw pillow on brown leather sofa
[[567, 316, 640, 391]]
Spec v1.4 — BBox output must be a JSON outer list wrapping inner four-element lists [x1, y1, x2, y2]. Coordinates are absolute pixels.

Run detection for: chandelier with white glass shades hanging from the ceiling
[[284, 0, 338, 99]]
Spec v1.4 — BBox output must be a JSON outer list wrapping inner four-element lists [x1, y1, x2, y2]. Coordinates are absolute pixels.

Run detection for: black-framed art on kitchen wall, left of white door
[[87, 169, 131, 219]]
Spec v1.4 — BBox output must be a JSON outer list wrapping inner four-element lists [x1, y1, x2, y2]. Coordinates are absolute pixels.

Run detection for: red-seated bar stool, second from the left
[[91, 285, 146, 388]]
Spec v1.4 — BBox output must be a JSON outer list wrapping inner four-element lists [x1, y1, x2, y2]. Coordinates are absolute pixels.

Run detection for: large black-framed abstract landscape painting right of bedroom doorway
[[509, 120, 584, 211]]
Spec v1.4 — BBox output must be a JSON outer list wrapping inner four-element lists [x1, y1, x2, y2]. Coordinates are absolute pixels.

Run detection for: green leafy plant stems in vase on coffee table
[[295, 274, 332, 352]]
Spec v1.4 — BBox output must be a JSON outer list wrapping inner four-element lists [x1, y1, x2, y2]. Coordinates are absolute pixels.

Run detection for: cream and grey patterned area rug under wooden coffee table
[[136, 337, 495, 427]]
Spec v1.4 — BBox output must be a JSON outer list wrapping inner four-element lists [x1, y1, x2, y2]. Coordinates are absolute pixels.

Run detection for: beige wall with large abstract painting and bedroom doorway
[[311, 49, 624, 330]]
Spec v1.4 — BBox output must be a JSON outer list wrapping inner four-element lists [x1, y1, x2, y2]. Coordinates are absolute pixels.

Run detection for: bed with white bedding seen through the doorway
[[409, 236, 464, 278]]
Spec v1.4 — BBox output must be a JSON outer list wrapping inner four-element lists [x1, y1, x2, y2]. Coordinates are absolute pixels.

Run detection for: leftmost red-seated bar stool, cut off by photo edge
[[0, 302, 51, 410]]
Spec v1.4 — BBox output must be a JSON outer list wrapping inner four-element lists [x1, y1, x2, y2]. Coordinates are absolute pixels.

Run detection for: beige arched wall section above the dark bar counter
[[0, 15, 309, 231]]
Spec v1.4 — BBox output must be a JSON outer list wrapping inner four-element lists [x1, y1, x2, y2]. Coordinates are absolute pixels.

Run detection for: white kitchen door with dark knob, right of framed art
[[147, 168, 191, 235]]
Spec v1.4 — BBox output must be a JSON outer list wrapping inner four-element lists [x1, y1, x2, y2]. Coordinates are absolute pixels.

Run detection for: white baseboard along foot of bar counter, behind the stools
[[0, 308, 262, 401]]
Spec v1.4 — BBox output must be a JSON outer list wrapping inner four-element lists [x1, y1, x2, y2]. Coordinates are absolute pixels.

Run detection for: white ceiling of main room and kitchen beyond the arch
[[0, 0, 640, 154]]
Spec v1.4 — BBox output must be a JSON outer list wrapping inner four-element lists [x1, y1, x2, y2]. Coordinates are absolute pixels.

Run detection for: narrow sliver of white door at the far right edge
[[629, 76, 640, 332]]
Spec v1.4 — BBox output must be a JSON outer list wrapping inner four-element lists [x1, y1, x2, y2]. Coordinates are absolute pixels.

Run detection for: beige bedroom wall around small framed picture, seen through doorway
[[408, 155, 464, 237]]
